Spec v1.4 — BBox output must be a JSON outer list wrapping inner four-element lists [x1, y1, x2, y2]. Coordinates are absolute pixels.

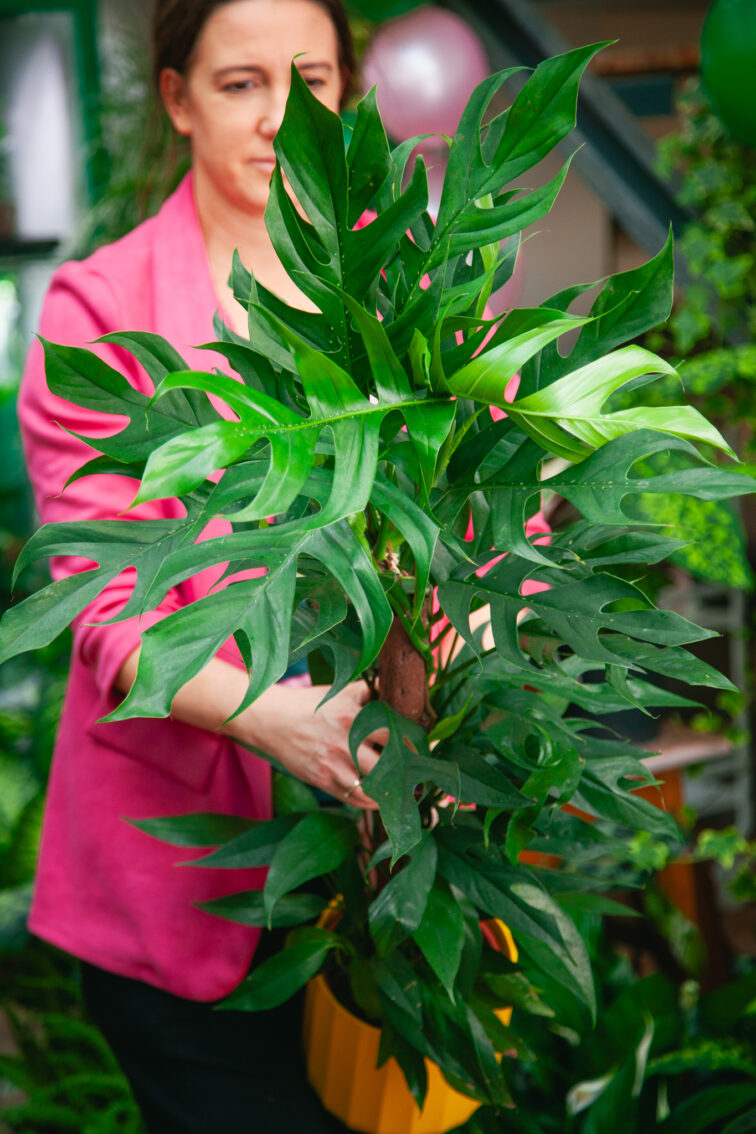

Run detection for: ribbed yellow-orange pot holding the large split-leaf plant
[[304, 922, 517, 1134]]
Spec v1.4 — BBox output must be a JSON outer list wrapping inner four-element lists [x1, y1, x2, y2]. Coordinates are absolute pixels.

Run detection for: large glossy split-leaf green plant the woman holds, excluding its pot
[[1, 41, 753, 1128]]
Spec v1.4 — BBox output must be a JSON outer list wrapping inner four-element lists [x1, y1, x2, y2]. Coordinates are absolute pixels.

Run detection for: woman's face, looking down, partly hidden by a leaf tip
[[161, 0, 342, 214]]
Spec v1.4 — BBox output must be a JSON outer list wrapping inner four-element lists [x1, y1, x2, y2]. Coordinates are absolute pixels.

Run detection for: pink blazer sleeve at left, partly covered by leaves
[[18, 262, 182, 695]]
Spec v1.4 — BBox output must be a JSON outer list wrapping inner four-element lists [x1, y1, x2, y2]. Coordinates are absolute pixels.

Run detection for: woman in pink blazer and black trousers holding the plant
[[19, 0, 382, 1134]]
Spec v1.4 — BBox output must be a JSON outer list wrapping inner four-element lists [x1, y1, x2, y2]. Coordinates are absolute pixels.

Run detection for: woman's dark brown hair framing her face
[[152, 0, 356, 104]]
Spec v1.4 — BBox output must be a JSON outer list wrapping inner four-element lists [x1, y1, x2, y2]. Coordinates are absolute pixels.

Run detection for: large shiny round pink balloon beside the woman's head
[[363, 6, 490, 141]]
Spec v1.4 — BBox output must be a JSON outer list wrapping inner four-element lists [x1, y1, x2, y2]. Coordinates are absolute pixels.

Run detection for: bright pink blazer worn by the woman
[[18, 177, 271, 1000]]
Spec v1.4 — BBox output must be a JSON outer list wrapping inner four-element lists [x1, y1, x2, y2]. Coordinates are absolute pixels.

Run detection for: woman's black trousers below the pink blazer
[[82, 934, 346, 1134]]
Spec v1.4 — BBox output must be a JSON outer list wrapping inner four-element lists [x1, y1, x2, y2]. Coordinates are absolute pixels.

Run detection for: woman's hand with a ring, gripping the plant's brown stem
[[236, 682, 388, 811]]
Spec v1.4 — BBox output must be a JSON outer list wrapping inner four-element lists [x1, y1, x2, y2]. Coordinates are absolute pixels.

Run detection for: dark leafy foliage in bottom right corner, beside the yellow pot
[[460, 914, 756, 1134]]
